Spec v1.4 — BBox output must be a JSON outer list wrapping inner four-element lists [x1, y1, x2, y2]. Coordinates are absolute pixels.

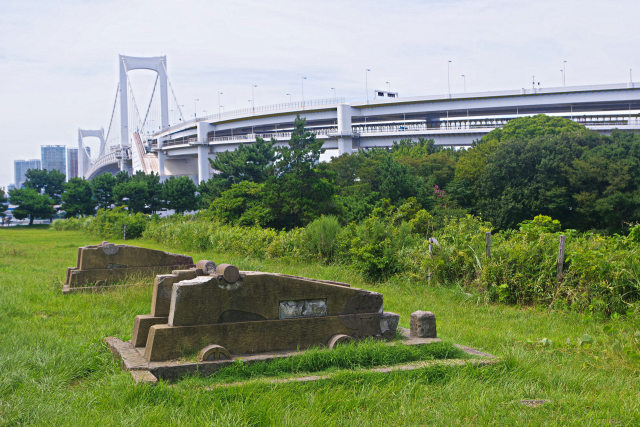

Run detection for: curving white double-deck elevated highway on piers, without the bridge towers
[[147, 83, 640, 182]]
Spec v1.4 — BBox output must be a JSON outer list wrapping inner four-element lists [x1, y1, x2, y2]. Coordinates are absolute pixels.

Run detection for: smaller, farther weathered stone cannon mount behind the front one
[[62, 242, 194, 293]]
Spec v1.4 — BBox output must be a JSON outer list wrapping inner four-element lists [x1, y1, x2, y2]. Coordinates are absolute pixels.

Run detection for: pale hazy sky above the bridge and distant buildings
[[0, 0, 640, 187]]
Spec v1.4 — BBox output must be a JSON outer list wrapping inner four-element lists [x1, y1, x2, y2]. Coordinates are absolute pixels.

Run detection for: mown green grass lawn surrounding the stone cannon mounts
[[0, 228, 640, 425]]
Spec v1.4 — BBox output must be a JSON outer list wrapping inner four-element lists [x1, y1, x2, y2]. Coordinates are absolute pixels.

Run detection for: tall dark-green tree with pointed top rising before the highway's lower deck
[[265, 116, 335, 228]]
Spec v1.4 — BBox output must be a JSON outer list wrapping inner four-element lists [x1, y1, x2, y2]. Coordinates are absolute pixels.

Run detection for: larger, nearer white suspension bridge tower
[[119, 55, 169, 178]]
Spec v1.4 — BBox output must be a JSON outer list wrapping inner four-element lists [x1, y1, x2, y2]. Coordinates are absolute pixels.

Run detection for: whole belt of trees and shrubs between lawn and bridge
[[41, 115, 640, 315]]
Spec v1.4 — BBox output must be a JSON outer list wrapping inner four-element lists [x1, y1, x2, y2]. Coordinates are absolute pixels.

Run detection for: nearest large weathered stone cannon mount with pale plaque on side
[[132, 261, 398, 362]]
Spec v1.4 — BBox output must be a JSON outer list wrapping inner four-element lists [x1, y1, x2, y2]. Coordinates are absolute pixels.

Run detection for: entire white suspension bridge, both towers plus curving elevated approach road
[[78, 55, 640, 183]]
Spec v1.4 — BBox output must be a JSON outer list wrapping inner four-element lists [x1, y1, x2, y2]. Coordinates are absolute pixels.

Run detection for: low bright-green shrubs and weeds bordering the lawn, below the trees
[[53, 211, 640, 316]]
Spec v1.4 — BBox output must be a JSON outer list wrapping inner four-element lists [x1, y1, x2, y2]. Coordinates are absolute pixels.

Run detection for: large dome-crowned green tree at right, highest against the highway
[[456, 115, 602, 229]]
